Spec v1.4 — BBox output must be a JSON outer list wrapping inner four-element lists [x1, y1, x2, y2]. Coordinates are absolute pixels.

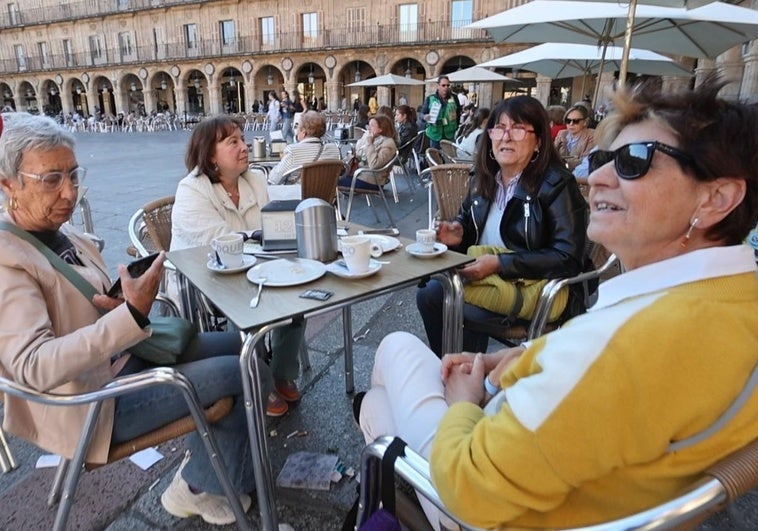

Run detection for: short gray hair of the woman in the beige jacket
[[0, 112, 76, 186]]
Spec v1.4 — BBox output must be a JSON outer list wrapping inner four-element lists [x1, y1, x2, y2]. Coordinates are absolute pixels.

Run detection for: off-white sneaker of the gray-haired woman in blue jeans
[[161, 452, 251, 525]]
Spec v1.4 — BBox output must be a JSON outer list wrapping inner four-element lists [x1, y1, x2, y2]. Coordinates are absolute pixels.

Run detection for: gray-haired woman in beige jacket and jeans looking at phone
[[0, 113, 265, 524]]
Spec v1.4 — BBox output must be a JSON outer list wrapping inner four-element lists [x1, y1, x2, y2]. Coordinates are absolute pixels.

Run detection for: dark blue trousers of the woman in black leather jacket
[[416, 280, 502, 358]]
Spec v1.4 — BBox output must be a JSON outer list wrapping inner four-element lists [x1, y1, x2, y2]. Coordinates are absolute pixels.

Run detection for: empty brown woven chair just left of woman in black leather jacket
[[421, 164, 471, 227]]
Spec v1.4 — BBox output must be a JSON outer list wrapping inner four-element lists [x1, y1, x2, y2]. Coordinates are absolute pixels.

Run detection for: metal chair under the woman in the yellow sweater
[[357, 437, 758, 531]]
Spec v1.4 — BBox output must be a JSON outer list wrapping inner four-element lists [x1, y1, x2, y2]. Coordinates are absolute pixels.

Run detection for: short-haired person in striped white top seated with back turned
[[268, 111, 341, 184]]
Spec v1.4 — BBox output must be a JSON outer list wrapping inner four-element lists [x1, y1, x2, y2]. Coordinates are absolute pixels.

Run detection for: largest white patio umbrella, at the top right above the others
[[468, 0, 758, 98]]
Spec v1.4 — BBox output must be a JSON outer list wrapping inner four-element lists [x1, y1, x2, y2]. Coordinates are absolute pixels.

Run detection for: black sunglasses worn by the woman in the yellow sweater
[[588, 142, 695, 180]]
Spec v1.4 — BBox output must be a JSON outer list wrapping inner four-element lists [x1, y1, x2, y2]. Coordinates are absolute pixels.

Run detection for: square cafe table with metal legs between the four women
[[168, 234, 471, 531]]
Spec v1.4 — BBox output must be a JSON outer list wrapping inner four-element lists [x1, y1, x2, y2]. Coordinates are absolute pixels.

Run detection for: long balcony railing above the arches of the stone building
[[0, 21, 490, 74]]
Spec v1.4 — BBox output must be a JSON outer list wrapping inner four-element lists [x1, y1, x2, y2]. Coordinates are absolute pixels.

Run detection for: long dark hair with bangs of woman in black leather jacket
[[474, 96, 561, 201]]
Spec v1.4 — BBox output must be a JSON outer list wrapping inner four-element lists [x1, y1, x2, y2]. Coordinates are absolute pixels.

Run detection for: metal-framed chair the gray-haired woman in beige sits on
[[0, 367, 250, 530]]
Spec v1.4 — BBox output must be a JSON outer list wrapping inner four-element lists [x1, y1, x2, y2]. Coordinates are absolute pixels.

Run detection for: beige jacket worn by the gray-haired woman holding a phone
[[0, 215, 150, 463]]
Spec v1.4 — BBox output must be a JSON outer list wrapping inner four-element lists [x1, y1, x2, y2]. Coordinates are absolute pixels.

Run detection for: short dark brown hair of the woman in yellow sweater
[[595, 76, 758, 245]]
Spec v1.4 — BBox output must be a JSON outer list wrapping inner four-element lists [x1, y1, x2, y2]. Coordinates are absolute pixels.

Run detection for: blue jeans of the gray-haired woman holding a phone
[[112, 332, 273, 494]]
